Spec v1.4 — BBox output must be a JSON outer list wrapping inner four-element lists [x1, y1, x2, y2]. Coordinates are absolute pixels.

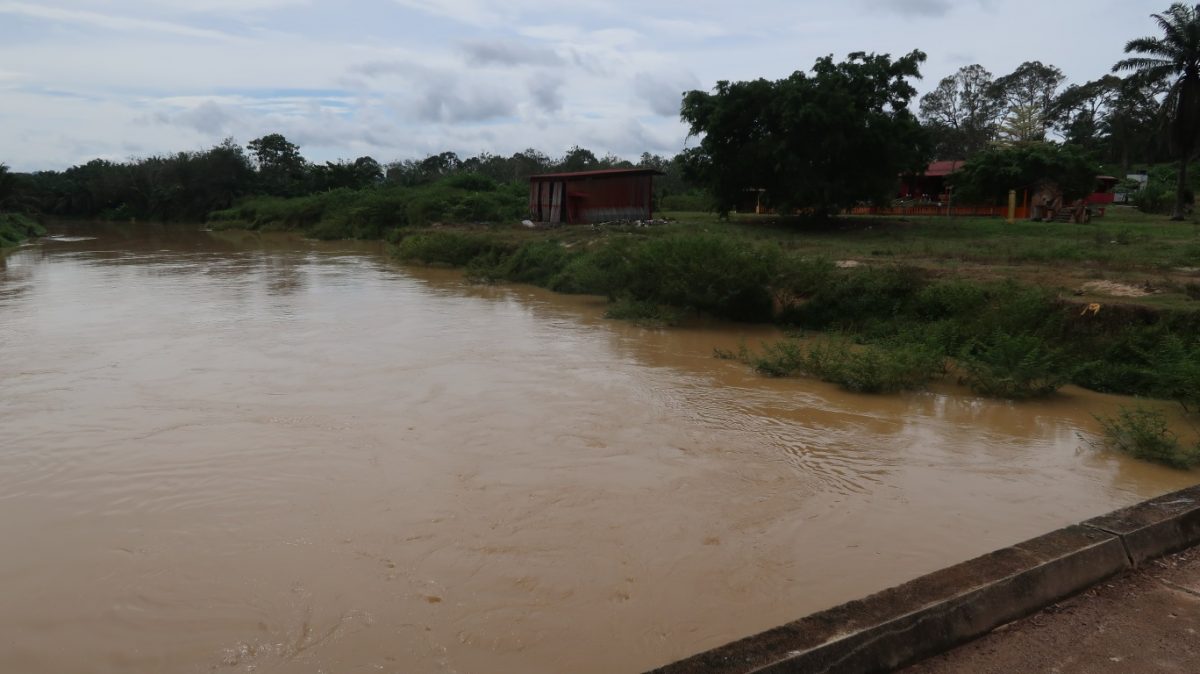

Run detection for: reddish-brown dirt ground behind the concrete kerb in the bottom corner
[[901, 547, 1200, 674]]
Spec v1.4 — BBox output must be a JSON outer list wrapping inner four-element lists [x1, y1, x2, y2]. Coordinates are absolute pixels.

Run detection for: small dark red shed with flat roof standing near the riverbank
[[529, 168, 662, 224]]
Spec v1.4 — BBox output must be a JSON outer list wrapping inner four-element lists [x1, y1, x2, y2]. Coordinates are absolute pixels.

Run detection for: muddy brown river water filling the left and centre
[[0, 224, 1198, 674]]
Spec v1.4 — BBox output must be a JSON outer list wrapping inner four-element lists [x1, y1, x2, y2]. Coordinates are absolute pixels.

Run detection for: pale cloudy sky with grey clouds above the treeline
[[0, 0, 1169, 170]]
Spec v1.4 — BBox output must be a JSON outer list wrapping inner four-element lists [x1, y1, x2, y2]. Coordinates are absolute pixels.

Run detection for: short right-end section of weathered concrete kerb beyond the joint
[[1084, 486, 1200, 566]]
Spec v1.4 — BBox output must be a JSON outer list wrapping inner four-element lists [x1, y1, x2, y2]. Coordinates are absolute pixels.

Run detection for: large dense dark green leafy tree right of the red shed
[[680, 52, 929, 215]]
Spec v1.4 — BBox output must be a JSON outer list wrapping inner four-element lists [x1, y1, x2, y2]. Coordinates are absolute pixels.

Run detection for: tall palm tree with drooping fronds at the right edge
[[1112, 2, 1200, 219]]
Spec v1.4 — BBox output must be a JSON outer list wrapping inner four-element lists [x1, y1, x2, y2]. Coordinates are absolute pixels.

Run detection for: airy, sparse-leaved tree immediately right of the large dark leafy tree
[[920, 64, 1002, 160]]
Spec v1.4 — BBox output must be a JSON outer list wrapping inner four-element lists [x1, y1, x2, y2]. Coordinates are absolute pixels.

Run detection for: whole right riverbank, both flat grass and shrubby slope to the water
[[394, 211, 1200, 404]]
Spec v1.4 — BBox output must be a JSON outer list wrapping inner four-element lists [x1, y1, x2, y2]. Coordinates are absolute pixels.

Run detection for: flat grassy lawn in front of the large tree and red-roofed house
[[657, 206, 1200, 309]]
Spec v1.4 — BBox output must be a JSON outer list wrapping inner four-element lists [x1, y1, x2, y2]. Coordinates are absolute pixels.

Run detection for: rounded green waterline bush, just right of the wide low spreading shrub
[[959, 332, 1072, 399]]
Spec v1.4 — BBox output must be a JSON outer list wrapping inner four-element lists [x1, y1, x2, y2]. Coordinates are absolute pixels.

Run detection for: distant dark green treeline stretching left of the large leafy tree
[[0, 133, 689, 222]]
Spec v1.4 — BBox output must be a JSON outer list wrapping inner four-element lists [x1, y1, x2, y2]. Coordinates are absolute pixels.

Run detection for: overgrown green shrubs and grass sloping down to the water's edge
[[386, 213, 1200, 404]]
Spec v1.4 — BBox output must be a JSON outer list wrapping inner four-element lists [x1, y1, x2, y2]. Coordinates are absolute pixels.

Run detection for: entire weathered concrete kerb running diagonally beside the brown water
[[654, 487, 1200, 674]]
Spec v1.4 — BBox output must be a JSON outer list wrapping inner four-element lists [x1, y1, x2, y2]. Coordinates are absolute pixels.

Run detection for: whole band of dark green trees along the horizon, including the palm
[[0, 4, 1200, 221]]
